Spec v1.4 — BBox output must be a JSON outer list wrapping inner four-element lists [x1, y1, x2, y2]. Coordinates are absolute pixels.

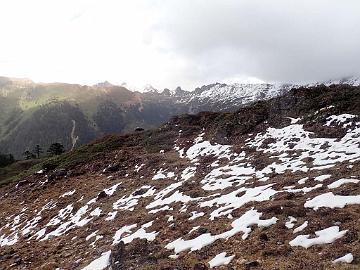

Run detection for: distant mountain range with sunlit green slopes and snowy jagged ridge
[[0, 77, 360, 158]]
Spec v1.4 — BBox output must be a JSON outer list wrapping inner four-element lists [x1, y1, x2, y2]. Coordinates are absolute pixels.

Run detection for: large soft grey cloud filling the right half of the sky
[[153, 0, 360, 82]]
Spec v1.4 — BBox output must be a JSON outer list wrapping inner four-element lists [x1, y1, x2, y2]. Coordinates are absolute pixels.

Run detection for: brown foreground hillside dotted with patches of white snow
[[0, 85, 360, 270]]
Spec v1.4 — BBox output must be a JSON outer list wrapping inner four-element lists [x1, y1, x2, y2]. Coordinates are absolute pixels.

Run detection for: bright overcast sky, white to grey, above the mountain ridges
[[0, 0, 360, 90]]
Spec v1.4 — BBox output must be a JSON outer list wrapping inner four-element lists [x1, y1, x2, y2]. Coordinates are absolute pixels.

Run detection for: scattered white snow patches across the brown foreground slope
[[0, 115, 360, 270]]
